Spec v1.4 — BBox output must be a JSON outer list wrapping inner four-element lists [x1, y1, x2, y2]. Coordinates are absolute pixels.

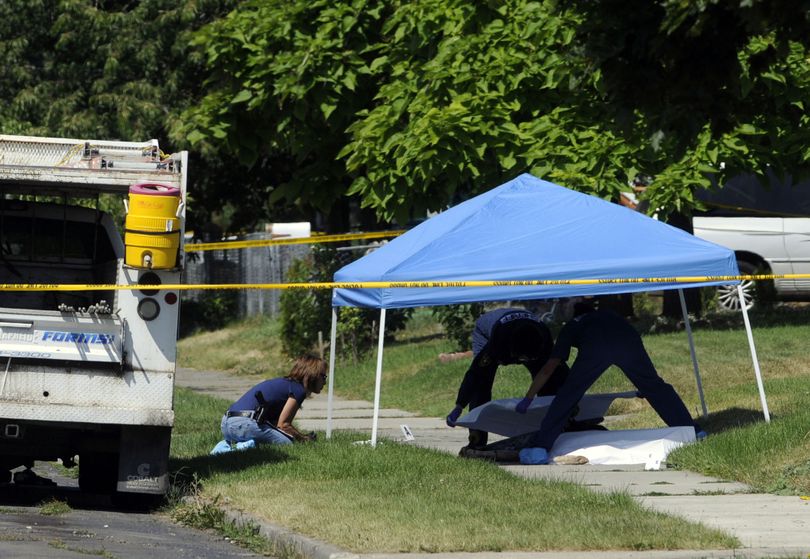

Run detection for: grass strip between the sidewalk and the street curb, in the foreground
[[167, 389, 739, 553]]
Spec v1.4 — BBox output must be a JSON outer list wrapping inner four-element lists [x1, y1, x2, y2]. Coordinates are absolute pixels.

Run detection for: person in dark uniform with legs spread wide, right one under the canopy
[[515, 303, 705, 464]]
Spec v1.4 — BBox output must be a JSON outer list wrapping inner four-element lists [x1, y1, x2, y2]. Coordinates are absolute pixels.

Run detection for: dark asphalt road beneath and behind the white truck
[[0, 464, 257, 559]]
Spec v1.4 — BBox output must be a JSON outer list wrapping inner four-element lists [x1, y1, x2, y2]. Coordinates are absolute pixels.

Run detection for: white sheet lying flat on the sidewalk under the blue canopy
[[549, 427, 695, 470]]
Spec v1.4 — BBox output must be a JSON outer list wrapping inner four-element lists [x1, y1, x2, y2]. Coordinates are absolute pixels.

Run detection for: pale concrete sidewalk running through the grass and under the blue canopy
[[177, 369, 810, 559]]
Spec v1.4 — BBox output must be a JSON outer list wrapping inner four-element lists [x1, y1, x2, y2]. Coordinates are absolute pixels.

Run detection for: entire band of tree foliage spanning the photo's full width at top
[[0, 0, 810, 227]]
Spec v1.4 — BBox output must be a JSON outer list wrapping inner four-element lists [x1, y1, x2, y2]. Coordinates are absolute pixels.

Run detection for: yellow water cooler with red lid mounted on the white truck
[[124, 183, 180, 270]]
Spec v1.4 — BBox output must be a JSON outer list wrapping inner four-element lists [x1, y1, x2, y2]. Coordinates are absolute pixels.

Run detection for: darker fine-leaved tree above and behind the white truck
[[0, 0, 246, 233]]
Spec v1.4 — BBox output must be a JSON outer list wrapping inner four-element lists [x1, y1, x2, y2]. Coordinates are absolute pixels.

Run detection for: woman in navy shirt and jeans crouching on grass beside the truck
[[211, 356, 327, 454]]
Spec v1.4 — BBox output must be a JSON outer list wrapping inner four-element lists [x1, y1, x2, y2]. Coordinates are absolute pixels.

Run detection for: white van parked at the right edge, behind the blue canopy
[[692, 175, 810, 310]]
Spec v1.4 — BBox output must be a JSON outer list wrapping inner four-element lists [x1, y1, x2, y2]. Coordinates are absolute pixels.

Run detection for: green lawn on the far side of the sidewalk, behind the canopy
[[179, 307, 810, 495]]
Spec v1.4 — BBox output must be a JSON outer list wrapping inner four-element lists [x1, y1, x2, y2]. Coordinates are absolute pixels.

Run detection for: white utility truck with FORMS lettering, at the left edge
[[0, 135, 188, 495]]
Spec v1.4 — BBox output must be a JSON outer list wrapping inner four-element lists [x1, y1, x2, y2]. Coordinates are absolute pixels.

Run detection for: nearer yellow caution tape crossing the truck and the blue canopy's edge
[[0, 274, 810, 291]]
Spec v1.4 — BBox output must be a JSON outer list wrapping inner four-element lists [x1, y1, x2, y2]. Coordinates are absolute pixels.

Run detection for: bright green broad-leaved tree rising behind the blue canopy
[[177, 0, 810, 221]]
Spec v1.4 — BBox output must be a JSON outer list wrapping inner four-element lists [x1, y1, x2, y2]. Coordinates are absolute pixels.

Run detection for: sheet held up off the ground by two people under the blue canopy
[[456, 391, 638, 437]]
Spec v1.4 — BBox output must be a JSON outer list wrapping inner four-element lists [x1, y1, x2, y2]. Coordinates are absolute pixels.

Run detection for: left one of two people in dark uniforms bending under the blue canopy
[[447, 309, 568, 448]]
